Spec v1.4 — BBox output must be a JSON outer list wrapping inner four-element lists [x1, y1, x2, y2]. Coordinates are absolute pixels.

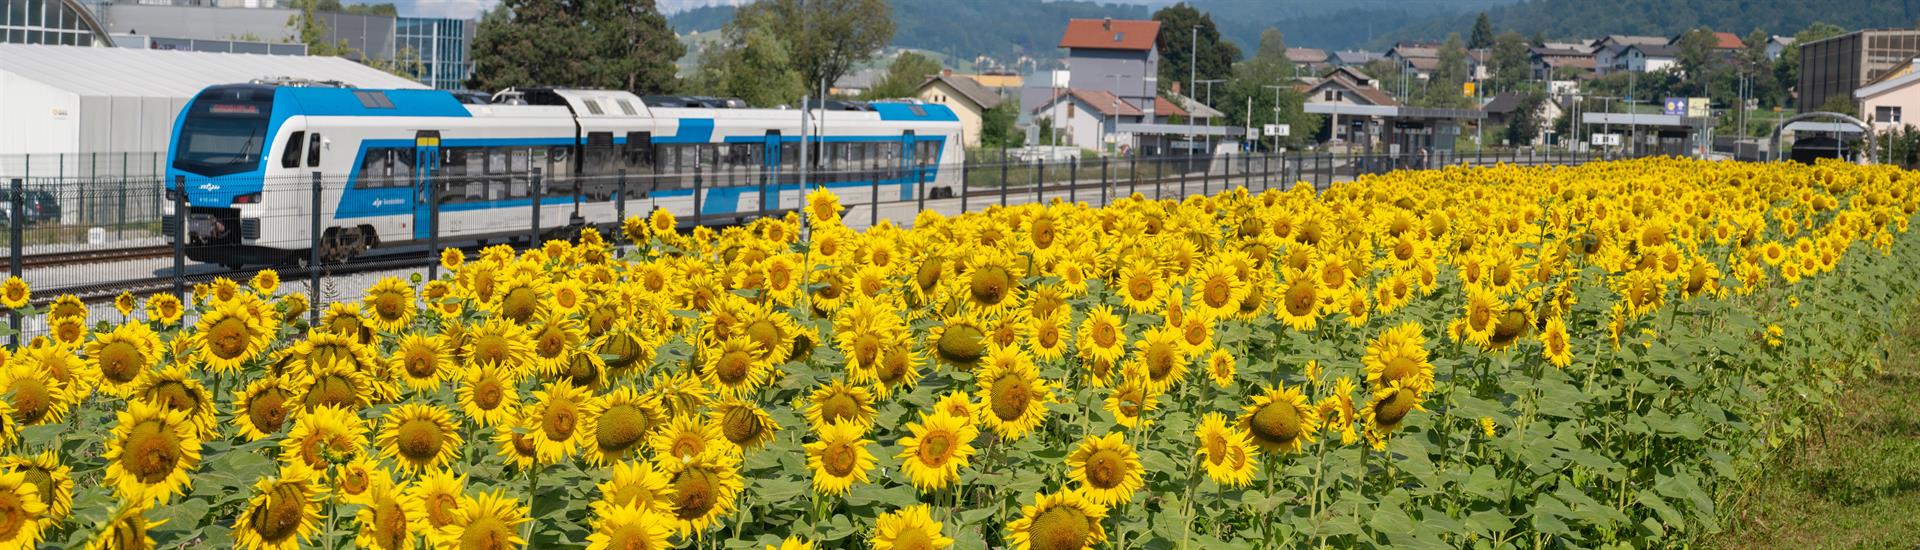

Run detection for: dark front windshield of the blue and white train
[[173, 87, 273, 175]]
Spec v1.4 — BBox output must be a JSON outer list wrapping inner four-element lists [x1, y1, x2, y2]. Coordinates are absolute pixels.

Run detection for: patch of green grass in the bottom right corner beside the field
[[1709, 300, 1920, 550]]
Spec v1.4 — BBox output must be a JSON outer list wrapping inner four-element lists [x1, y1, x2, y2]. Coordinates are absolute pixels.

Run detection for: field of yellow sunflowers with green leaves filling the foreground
[[0, 160, 1920, 550]]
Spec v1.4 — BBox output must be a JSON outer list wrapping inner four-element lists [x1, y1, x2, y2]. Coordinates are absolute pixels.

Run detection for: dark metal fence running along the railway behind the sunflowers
[[0, 150, 1628, 333]]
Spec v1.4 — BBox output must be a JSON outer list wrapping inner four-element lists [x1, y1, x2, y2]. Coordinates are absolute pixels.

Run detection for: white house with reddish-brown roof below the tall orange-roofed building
[[1031, 88, 1188, 154]]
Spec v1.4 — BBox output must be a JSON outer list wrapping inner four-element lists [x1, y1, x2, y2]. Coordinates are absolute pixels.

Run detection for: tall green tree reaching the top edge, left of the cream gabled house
[[735, 0, 893, 87]]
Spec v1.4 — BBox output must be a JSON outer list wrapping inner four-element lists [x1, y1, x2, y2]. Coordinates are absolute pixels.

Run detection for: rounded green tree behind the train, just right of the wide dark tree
[[682, 6, 808, 108]]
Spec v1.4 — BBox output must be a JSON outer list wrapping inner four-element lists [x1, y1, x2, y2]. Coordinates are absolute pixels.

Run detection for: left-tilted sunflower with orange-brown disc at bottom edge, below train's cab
[[232, 467, 324, 550]]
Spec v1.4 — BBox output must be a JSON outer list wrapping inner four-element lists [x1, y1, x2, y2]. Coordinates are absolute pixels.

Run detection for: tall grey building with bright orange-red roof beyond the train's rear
[[1060, 17, 1160, 115]]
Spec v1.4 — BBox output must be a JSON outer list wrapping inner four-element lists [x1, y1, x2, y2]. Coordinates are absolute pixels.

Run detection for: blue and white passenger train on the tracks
[[163, 83, 964, 265]]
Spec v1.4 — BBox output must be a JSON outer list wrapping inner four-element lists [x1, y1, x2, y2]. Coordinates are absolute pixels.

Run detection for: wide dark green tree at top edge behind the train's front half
[[468, 0, 685, 94]]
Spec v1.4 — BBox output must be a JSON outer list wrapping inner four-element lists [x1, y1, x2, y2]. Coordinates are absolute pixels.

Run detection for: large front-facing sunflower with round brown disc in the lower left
[[102, 400, 200, 506]]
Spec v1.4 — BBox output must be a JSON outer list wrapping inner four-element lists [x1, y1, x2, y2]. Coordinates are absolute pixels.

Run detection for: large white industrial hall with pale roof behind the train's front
[[0, 44, 424, 179]]
